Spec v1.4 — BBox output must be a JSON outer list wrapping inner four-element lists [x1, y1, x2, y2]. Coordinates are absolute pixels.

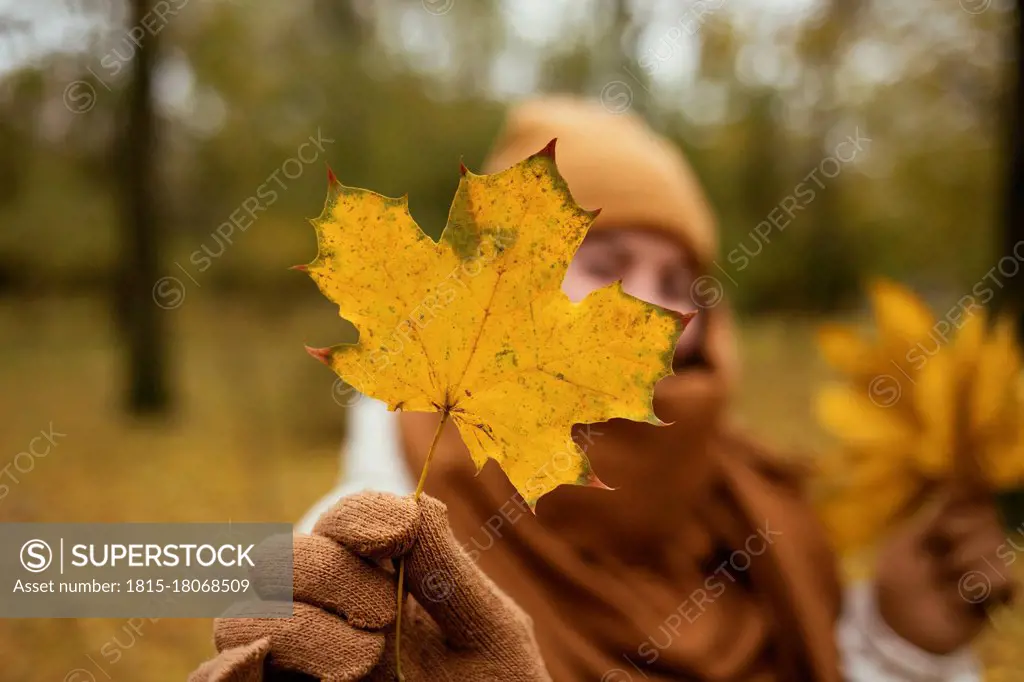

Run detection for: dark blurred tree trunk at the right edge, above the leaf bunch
[[1001, 0, 1024, 338]]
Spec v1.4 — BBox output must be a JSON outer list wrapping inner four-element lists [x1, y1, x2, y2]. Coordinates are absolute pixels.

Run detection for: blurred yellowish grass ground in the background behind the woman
[[0, 292, 1024, 682]]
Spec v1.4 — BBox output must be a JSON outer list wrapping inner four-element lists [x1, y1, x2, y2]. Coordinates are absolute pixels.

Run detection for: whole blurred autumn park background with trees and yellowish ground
[[0, 0, 1024, 682]]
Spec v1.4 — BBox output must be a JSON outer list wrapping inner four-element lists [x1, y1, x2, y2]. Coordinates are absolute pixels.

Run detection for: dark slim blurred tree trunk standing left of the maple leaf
[[115, 0, 170, 415]]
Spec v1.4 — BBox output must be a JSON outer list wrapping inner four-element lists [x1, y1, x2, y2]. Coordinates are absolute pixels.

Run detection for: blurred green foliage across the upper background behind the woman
[[0, 0, 1011, 311]]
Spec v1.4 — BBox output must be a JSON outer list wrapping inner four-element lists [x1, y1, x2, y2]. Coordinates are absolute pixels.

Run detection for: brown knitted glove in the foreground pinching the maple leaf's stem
[[189, 493, 551, 682]]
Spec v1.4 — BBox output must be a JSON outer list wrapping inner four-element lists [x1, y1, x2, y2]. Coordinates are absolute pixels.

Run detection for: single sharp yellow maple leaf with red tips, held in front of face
[[296, 141, 689, 508]]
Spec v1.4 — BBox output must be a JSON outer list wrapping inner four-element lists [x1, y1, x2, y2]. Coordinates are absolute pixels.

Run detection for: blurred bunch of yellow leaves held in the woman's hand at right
[[817, 282, 1024, 552]]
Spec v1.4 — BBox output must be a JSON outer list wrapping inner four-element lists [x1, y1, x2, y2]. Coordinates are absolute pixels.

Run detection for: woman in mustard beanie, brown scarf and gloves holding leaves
[[195, 98, 1012, 682]]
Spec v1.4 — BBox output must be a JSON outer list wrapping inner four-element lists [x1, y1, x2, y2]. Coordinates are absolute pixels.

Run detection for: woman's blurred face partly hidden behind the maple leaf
[[562, 229, 702, 369]]
